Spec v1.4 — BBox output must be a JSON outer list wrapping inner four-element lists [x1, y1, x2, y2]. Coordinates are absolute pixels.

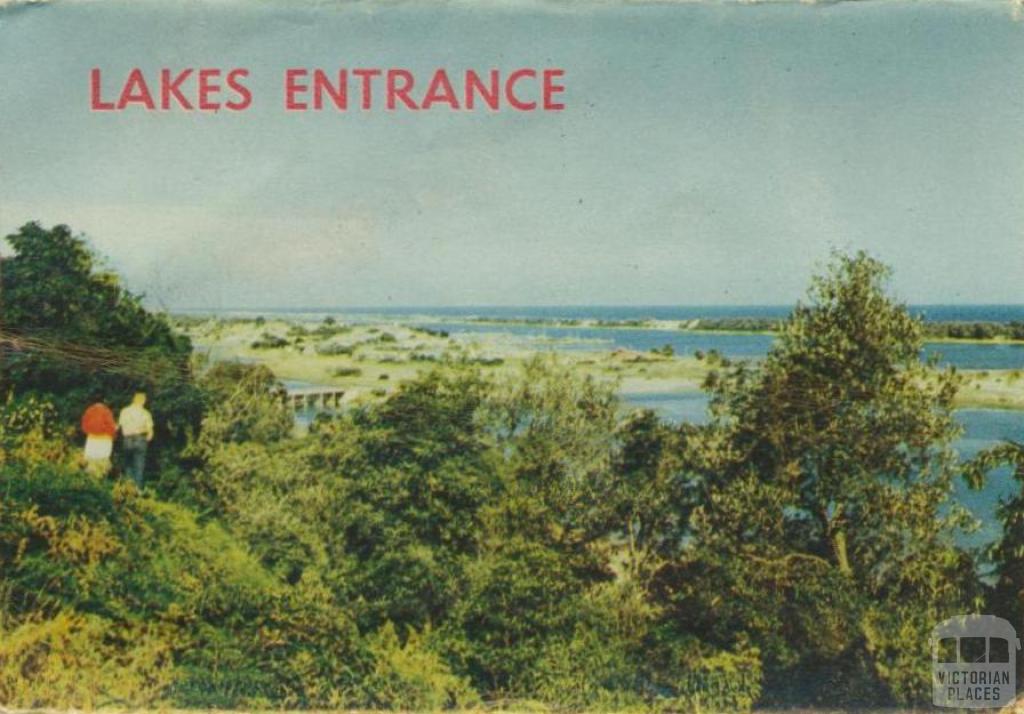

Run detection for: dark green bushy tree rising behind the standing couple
[[0, 222, 202, 465]]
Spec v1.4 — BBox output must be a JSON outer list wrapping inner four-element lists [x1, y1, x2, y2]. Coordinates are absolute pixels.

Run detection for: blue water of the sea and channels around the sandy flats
[[203, 305, 1024, 546]]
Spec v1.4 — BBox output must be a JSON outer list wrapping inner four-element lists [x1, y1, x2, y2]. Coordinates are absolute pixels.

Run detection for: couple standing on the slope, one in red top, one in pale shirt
[[82, 391, 153, 489]]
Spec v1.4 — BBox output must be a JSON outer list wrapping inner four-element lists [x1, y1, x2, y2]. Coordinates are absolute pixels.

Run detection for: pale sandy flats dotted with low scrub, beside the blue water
[[177, 319, 1024, 411]]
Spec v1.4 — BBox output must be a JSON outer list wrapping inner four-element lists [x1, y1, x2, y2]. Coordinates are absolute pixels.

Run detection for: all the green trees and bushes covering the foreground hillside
[[0, 225, 1024, 711]]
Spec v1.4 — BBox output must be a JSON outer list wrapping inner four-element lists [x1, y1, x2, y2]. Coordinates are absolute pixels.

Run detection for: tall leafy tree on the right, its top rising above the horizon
[[663, 248, 973, 703]]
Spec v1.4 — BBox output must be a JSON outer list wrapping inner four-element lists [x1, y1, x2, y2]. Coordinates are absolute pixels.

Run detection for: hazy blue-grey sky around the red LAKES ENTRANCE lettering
[[0, 0, 1024, 309]]
